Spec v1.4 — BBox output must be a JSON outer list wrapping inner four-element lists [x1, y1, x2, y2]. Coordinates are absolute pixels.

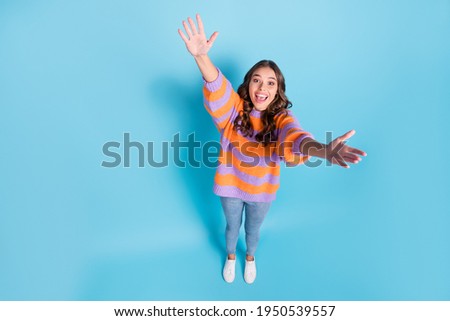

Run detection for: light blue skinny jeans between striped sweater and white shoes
[[220, 197, 271, 256]]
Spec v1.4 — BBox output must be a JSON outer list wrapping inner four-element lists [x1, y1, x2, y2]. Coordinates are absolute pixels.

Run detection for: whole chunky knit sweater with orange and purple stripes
[[203, 70, 312, 202]]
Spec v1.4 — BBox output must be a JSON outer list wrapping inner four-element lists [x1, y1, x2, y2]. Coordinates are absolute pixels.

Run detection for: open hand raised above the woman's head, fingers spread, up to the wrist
[[178, 14, 219, 57]]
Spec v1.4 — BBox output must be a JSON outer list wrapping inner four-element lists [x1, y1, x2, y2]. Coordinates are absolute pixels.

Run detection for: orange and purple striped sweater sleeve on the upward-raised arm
[[203, 69, 239, 132]]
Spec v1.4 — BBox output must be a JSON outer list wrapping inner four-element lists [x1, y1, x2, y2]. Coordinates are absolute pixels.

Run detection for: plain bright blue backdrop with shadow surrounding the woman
[[0, 0, 450, 300]]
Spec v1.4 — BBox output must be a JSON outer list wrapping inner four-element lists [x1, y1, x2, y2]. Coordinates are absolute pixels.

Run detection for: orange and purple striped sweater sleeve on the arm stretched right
[[277, 111, 313, 166]]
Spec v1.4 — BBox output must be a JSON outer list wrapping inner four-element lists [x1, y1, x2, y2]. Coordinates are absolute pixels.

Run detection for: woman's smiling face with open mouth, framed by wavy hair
[[248, 67, 278, 111]]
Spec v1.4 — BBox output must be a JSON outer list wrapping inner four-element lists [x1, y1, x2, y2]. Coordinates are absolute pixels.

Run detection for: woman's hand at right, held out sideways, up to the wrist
[[325, 130, 367, 168]]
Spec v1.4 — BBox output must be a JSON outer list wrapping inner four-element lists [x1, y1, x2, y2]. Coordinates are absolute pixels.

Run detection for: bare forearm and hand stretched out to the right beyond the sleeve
[[300, 130, 367, 168]]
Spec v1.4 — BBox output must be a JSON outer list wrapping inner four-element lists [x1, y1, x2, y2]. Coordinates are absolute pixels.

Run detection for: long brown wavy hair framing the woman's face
[[233, 60, 292, 146]]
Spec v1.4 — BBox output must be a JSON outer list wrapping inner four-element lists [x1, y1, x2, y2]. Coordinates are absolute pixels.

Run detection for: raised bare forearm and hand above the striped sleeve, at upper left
[[178, 14, 219, 82]]
